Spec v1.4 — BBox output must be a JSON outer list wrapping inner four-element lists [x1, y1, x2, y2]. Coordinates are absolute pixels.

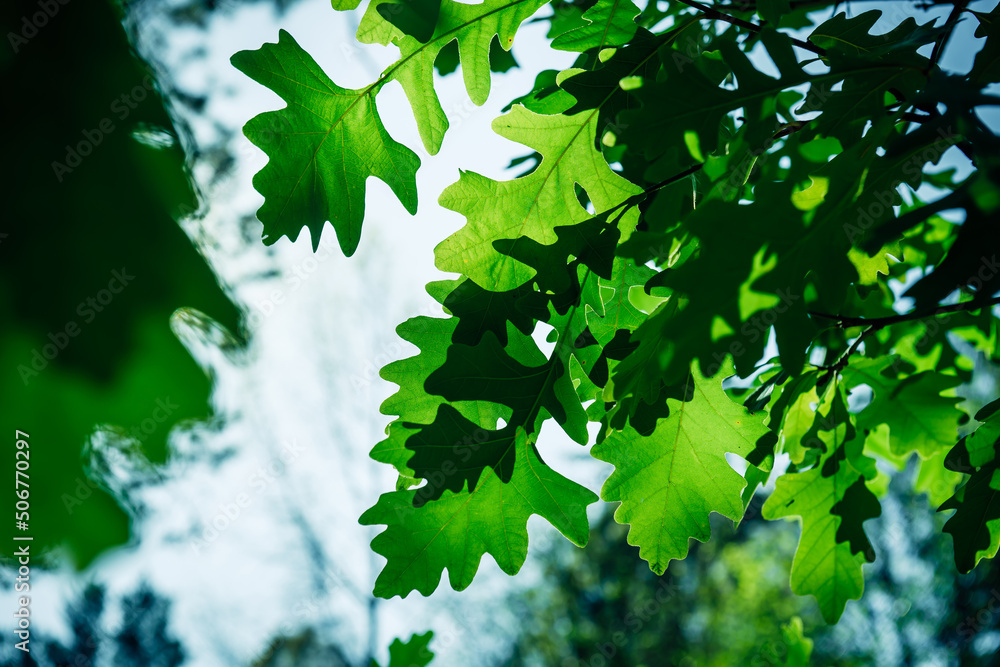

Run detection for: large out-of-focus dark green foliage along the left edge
[[0, 0, 239, 567]]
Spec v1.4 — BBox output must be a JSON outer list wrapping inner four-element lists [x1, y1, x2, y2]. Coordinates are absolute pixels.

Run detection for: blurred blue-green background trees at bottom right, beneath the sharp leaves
[[505, 466, 1000, 667]]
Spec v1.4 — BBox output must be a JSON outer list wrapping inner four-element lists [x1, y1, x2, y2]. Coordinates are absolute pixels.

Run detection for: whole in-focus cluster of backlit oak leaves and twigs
[[233, 0, 1000, 622]]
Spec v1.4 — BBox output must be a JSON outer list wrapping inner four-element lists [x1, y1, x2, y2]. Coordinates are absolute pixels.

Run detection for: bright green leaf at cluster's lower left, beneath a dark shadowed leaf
[[360, 430, 597, 598]]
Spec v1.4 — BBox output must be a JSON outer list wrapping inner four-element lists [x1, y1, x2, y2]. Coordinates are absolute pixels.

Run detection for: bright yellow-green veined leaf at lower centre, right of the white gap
[[591, 364, 768, 574]]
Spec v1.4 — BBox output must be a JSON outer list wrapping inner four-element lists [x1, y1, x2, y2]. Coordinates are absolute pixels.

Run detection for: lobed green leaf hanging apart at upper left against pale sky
[[232, 30, 420, 256]]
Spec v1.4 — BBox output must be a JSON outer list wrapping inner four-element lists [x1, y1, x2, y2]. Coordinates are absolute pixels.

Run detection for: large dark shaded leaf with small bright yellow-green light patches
[[616, 122, 944, 396]]
